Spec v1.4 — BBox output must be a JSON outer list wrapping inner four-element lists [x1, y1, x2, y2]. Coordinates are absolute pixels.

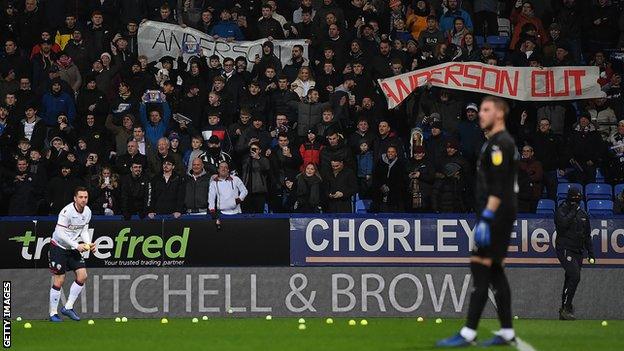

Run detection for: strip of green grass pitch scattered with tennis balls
[[11, 316, 624, 351]]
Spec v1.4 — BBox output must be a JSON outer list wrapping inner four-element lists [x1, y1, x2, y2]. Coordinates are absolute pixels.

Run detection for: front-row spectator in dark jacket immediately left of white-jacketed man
[[184, 158, 211, 215]]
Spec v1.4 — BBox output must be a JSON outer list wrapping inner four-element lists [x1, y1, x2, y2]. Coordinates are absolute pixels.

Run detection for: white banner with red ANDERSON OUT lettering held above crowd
[[378, 62, 605, 108]]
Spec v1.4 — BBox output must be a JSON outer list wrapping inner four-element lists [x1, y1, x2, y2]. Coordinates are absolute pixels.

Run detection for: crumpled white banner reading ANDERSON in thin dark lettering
[[138, 21, 308, 65]]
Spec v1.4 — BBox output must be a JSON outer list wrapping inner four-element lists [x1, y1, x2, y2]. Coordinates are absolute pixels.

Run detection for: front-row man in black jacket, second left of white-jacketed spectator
[[147, 156, 185, 218]]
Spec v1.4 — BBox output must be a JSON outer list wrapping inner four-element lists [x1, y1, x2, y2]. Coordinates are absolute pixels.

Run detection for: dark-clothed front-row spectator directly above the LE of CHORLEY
[[406, 145, 435, 212]]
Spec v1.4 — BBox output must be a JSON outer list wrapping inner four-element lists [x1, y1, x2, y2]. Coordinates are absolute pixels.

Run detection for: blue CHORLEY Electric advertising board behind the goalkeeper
[[290, 215, 624, 267]]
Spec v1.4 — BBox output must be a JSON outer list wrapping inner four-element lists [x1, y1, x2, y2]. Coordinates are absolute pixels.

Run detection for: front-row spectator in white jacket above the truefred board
[[208, 162, 248, 218]]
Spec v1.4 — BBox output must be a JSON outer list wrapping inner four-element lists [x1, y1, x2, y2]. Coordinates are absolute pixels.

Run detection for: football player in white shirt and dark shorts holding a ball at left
[[48, 187, 95, 322]]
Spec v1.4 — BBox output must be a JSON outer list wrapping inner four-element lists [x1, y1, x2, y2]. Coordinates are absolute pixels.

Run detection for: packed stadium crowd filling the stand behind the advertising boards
[[0, 0, 624, 218]]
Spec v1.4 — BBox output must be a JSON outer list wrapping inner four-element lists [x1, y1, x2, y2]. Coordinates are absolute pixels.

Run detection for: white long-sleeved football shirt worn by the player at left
[[52, 202, 91, 250]]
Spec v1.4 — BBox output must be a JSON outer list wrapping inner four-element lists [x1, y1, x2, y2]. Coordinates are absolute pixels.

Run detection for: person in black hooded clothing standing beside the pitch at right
[[555, 188, 596, 320]]
